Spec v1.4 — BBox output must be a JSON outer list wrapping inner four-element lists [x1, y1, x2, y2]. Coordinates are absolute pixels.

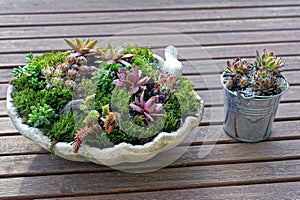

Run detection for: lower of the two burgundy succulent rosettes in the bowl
[[129, 91, 165, 123]]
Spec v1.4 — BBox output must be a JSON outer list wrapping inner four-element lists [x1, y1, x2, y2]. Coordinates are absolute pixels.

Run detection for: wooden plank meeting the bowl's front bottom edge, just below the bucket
[[0, 140, 300, 178]]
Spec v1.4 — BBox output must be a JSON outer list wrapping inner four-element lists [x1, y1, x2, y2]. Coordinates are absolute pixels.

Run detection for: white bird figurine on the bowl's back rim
[[162, 46, 183, 78]]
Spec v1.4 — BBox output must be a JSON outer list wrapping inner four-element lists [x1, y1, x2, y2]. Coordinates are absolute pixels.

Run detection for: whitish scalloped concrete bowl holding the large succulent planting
[[6, 85, 204, 166]]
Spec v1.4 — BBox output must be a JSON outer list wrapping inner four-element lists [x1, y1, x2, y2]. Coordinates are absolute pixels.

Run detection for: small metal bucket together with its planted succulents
[[221, 49, 289, 142]]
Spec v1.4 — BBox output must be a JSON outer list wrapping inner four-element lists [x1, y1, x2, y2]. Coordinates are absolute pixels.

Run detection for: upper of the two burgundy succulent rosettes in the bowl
[[114, 65, 150, 94]]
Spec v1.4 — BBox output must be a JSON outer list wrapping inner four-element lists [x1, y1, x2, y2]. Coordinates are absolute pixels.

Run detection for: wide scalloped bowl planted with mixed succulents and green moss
[[7, 39, 204, 165]]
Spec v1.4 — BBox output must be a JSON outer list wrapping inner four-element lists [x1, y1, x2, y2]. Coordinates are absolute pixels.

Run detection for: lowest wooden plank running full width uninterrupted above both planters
[[0, 17, 300, 41]]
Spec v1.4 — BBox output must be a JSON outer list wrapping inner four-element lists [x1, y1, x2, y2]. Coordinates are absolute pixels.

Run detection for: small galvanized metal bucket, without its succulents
[[221, 75, 289, 142]]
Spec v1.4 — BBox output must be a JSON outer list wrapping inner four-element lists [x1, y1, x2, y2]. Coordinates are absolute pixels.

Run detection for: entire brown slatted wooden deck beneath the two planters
[[0, 0, 300, 199]]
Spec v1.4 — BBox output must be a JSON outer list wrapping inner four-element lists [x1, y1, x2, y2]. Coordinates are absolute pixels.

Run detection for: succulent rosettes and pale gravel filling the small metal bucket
[[222, 49, 284, 97]]
